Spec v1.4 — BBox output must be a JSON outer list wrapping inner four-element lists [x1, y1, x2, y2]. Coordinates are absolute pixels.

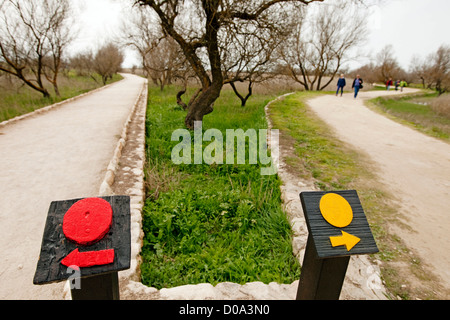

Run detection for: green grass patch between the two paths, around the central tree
[[141, 86, 300, 288]]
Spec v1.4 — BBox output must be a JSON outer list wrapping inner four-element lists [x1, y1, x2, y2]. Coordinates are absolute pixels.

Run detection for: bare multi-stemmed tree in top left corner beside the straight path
[[0, 0, 71, 97]]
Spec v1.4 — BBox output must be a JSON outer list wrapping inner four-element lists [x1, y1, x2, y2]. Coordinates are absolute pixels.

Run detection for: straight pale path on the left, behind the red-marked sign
[[0, 74, 145, 299]]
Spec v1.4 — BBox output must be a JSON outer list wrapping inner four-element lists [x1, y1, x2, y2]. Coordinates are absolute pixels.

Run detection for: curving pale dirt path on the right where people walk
[[308, 89, 450, 296]]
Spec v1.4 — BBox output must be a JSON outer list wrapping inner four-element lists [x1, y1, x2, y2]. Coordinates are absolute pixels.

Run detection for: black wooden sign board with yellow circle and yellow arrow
[[300, 190, 378, 259]]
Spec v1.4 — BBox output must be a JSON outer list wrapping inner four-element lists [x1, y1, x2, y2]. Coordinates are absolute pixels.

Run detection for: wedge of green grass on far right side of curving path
[[370, 93, 450, 141]]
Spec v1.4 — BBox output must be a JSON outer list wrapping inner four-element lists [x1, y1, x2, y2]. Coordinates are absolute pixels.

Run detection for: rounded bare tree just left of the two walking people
[[279, 1, 367, 90]]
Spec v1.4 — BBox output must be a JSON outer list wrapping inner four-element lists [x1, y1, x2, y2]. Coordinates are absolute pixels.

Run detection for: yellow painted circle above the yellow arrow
[[320, 193, 353, 228]]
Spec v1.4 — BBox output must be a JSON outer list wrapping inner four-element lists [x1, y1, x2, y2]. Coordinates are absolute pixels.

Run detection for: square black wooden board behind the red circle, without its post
[[33, 196, 131, 284]]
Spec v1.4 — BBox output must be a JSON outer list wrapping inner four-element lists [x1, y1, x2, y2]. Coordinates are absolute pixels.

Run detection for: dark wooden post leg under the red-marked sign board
[[70, 271, 120, 300]]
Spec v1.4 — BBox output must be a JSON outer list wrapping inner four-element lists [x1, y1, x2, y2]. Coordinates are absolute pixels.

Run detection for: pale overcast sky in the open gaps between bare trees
[[72, 0, 450, 69]]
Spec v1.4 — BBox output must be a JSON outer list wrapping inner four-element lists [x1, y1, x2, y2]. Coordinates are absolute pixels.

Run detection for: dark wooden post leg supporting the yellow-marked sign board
[[297, 235, 350, 300]]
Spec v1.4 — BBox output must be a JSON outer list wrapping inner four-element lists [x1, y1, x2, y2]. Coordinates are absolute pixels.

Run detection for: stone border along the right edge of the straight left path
[[93, 76, 151, 299]]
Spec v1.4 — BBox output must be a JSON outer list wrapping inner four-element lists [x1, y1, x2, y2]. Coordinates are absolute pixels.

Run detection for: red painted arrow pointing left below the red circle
[[61, 248, 114, 268]]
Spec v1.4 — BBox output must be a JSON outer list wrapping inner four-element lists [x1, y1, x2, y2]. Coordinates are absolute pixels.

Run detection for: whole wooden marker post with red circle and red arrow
[[33, 196, 131, 300]]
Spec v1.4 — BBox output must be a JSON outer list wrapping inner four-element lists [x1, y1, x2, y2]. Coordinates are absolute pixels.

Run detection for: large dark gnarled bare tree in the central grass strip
[[136, 0, 323, 129]]
